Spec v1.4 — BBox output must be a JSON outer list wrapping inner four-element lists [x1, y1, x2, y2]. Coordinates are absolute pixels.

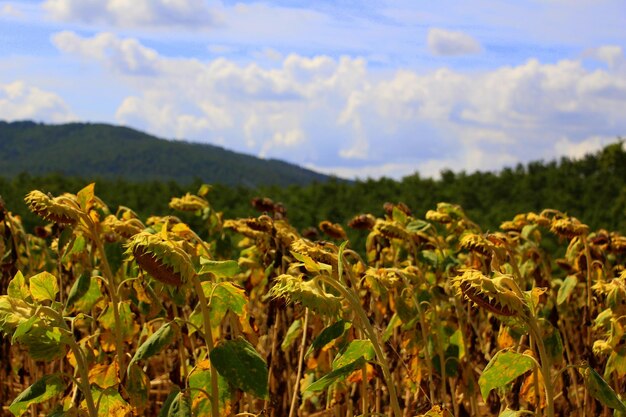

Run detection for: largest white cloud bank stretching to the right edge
[[54, 32, 626, 178]]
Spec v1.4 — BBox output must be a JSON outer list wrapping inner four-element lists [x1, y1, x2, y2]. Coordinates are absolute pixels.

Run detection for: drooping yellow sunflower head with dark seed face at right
[[453, 269, 527, 316]]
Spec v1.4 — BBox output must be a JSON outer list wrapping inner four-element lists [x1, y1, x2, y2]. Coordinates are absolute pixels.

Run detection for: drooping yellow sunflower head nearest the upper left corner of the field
[[24, 190, 80, 224]]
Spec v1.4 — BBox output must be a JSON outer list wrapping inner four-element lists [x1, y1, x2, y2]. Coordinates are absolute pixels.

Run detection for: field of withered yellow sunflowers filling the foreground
[[0, 184, 626, 417]]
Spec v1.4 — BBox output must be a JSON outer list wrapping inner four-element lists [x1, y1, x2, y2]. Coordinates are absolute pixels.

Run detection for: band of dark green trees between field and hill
[[0, 142, 626, 240]]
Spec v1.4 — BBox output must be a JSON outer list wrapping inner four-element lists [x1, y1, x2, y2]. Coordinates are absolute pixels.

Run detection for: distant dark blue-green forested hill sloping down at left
[[0, 122, 328, 187]]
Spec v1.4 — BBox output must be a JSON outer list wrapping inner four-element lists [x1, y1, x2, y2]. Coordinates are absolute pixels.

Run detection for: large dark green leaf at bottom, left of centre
[[209, 337, 268, 398]]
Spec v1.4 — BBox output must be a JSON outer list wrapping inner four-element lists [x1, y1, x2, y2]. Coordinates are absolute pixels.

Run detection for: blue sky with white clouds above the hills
[[0, 0, 626, 179]]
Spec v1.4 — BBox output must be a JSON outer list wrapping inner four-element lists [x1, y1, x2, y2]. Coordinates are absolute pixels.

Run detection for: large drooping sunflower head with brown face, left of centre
[[126, 232, 195, 286]]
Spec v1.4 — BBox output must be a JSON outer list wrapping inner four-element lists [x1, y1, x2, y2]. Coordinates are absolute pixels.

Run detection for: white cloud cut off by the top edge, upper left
[[43, 0, 220, 29]]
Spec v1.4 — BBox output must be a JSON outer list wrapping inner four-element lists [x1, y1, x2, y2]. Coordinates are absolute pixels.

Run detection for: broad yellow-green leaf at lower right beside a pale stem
[[478, 350, 535, 399]]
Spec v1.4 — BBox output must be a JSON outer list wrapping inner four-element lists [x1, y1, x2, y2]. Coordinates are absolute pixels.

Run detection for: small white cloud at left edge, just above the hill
[[0, 81, 75, 123]]
